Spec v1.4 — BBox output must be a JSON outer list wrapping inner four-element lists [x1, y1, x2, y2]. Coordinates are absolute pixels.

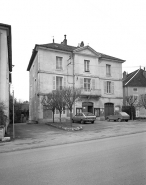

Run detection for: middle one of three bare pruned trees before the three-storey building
[[53, 90, 66, 123]]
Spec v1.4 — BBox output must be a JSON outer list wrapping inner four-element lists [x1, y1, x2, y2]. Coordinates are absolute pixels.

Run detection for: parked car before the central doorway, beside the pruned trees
[[72, 112, 96, 124]]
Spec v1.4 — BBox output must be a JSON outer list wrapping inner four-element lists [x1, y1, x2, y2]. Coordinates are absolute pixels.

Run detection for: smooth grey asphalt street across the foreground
[[0, 132, 146, 185]]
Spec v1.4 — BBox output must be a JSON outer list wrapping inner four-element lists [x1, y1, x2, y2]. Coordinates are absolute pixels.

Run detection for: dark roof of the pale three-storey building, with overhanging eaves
[[27, 43, 125, 71]]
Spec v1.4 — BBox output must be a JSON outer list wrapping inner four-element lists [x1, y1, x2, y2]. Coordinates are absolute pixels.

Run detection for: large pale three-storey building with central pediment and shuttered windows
[[27, 35, 124, 122]]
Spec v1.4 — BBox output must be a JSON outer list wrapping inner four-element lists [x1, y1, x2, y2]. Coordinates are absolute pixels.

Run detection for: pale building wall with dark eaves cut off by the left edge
[[0, 23, 12, 128]]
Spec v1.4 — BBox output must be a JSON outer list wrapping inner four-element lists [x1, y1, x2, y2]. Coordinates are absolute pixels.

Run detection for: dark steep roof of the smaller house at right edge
[[123, 69, 146, 87]]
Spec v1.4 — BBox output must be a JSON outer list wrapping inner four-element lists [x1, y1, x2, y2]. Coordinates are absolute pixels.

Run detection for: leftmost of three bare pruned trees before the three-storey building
[[41, 92, 56, 123]]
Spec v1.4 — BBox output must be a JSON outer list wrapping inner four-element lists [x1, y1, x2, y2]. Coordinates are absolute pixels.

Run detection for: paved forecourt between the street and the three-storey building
[[0, 121, 146, 153]]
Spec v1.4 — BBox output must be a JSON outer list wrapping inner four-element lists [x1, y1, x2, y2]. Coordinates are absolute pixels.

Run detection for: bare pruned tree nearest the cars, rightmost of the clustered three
[[63, 87, 81, 126]]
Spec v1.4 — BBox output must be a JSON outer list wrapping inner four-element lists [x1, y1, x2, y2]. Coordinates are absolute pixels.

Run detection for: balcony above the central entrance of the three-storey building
[[81, 89, 101, 97]]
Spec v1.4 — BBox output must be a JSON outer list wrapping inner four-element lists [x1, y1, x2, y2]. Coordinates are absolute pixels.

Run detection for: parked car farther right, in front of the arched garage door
[[106, 112, 130, 122]]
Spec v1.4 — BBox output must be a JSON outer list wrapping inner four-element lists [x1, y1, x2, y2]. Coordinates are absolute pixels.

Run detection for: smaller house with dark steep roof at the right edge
[[123, 68, 146, 118]]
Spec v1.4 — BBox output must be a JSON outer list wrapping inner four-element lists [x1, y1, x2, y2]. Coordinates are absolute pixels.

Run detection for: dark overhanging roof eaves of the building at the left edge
[[0, 23, 12, 72]]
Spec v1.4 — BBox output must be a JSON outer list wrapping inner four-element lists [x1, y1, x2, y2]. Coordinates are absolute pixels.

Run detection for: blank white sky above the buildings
[[0, 0, 146, 101]]
